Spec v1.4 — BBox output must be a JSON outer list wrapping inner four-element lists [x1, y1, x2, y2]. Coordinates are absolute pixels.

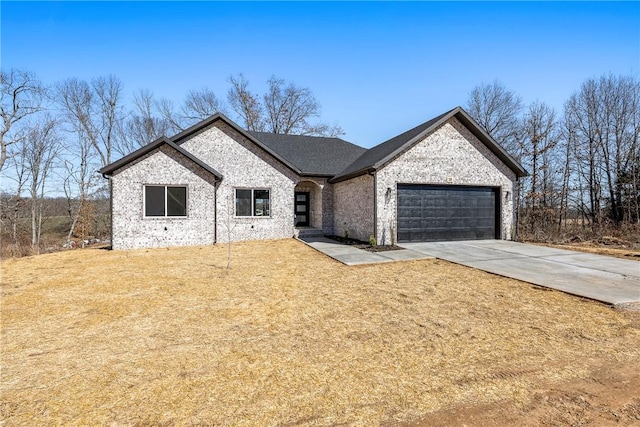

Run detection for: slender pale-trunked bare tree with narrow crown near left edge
[[23, 115, 61, 252]]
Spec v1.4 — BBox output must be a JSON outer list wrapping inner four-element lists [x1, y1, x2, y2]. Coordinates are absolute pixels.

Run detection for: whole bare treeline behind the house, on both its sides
[[0, 69, 640, 254]]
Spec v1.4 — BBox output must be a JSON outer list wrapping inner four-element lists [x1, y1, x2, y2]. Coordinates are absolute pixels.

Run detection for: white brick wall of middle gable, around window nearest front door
[[182, 122, 299, 242]]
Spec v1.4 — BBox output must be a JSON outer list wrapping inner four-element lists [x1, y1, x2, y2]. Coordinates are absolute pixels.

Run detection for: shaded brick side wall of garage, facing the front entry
[[333, 175, 374, 241]]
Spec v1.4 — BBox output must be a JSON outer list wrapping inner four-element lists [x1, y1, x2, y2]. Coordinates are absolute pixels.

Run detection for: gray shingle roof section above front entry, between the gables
[[247, 131, 367, 176]]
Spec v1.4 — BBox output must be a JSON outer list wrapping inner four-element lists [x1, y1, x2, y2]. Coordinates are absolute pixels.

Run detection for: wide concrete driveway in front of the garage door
[[400, 240, 640, 305]]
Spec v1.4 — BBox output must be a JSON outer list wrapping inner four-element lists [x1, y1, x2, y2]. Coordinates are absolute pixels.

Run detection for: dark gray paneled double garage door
[[398, 184, 500, 242]]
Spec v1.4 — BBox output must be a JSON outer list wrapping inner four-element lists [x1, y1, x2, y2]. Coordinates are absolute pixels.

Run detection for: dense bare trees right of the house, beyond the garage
[[467, 75, 640, 245]]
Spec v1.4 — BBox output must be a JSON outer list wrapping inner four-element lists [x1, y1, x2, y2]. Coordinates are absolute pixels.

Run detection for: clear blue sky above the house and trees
[[0, 0, 640, 147]]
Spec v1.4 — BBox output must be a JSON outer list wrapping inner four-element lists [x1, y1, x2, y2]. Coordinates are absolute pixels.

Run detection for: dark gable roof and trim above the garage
[[332, 107, 527, 182]]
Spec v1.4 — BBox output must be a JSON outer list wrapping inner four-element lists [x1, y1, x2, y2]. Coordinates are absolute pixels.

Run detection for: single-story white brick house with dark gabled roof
[[100, 107, 526, 249]]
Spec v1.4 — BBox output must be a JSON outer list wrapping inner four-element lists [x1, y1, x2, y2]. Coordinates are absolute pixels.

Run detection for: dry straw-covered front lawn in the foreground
[[0, 240, 640, 426]]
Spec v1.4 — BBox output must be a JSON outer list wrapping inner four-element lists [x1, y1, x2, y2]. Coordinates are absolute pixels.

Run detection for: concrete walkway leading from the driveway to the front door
[[298, 237, 434, 265]]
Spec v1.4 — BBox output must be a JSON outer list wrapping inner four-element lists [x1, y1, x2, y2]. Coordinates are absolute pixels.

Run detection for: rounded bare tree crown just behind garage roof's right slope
[[466, 80, 522, 157]]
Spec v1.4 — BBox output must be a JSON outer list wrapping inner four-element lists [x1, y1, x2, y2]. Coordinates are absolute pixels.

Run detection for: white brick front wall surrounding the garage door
[[376, 117, 516, 244]]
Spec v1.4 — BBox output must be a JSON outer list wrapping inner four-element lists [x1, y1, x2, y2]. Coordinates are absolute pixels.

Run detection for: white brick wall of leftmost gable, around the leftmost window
[[111, 145, 216, 249]]
